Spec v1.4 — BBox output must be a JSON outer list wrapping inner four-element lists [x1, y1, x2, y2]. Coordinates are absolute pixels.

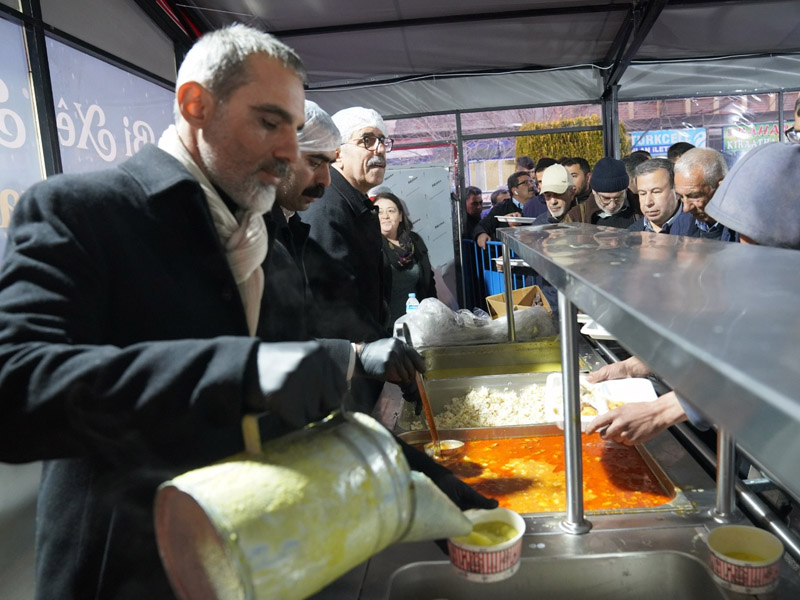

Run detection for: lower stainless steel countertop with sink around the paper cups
[[354, 433, 800, 600]]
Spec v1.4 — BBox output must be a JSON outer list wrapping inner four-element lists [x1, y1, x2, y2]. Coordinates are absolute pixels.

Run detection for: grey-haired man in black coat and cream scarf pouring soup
[[0, 26, 424, 600]]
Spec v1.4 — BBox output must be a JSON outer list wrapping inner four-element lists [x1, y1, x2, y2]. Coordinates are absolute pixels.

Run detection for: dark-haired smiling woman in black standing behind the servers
[[375, 192, 436, 323]]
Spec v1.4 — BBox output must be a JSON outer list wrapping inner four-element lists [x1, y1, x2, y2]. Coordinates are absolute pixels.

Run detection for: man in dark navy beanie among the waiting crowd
[[589, 157, 641, 229]]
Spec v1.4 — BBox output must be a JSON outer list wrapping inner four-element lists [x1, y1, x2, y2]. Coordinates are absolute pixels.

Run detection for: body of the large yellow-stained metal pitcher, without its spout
[[155, 414, 413, 600]]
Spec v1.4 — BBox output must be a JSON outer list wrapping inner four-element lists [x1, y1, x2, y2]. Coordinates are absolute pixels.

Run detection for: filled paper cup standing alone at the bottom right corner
[[708, 525, 783, 594]]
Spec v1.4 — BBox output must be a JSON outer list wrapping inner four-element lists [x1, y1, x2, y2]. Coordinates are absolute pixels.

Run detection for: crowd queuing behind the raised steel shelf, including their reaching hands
[[462, 124, 800, 445]]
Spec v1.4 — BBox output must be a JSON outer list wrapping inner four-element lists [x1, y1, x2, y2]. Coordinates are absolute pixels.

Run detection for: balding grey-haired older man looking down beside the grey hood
[[675, 148, 736, 242]]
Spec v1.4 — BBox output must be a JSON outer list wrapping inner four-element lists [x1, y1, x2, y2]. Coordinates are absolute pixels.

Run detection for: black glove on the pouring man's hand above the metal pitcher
[[249, 342, 347, 427]]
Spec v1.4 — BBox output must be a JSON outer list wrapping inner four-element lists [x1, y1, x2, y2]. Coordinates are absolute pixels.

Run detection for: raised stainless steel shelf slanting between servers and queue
[[500, 224, 800, 497]]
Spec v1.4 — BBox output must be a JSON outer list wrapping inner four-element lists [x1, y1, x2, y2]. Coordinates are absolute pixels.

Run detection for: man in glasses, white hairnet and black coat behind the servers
[[303, 107, 393, 412]]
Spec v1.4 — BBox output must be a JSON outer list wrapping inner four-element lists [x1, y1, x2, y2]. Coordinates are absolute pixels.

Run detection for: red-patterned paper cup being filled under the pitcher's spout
[[447, 508, 525, 582]]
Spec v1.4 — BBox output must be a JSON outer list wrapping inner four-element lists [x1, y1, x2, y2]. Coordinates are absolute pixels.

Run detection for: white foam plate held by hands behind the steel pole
[[544, 373, 657, 431]]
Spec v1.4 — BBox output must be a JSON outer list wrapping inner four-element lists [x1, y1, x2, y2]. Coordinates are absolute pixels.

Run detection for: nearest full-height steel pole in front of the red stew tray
[[558, 291, 592, 534]]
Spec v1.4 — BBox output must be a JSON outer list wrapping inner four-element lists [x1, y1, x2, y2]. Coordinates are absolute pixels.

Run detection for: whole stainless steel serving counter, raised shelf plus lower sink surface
[[320, 224, 800, 600]]
